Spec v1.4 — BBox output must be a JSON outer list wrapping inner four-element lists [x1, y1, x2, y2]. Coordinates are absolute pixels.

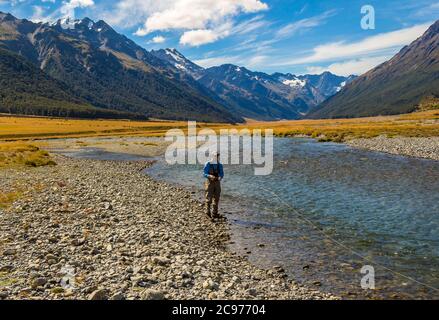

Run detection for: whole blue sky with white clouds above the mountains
[[0, 0, 439, 75]]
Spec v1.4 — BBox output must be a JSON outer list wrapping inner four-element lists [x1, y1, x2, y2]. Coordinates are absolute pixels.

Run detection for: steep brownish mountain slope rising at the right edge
[[309, 21, 439, 118]]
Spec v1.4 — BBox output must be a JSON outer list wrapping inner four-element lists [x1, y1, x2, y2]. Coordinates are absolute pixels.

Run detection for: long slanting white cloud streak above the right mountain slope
[[275, 23, 431, 66]]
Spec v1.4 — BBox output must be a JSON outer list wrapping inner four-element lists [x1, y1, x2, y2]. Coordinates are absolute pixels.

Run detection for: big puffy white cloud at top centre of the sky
[[104, 0, 268, 46]]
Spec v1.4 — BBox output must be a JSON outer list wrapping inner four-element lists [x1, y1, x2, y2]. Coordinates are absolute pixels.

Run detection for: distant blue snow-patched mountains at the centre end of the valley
[[151, 49, 356, 120]]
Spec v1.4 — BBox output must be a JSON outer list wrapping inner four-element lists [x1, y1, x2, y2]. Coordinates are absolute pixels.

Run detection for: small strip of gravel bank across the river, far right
[[346, 136, 439, 160]]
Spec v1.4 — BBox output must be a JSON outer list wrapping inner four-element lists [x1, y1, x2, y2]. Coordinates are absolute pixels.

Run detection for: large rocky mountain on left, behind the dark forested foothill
[[0, 14, 241, 122]]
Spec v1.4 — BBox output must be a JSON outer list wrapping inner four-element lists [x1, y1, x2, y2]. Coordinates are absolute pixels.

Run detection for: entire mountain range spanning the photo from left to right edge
[[0, 12, 439, 123]]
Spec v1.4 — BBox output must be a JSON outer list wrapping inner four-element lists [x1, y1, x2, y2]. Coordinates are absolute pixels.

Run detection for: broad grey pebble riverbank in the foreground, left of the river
[[0, 156, 335, 300]]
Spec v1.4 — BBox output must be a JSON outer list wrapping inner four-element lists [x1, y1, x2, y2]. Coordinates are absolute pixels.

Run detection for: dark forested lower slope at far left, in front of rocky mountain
[[0, 49, 146, 119]]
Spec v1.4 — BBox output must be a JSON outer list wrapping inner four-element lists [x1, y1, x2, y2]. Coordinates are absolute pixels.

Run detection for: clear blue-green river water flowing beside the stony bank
[[147, 138, 439, 299]]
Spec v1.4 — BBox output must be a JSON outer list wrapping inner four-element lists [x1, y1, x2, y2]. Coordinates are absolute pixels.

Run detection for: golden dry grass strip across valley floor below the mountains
[[0, 110, 439, 142]]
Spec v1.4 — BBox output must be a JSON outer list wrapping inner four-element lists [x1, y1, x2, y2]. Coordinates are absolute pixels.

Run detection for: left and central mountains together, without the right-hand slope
[[0, 13, 356, 122]]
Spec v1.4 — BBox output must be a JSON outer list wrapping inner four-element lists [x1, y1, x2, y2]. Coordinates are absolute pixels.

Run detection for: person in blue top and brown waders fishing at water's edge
[[204, 152, 224, 220]]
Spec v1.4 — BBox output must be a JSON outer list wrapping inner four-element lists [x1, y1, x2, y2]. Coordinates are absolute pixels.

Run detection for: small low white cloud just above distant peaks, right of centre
[[307, 56, 391, 76]]
